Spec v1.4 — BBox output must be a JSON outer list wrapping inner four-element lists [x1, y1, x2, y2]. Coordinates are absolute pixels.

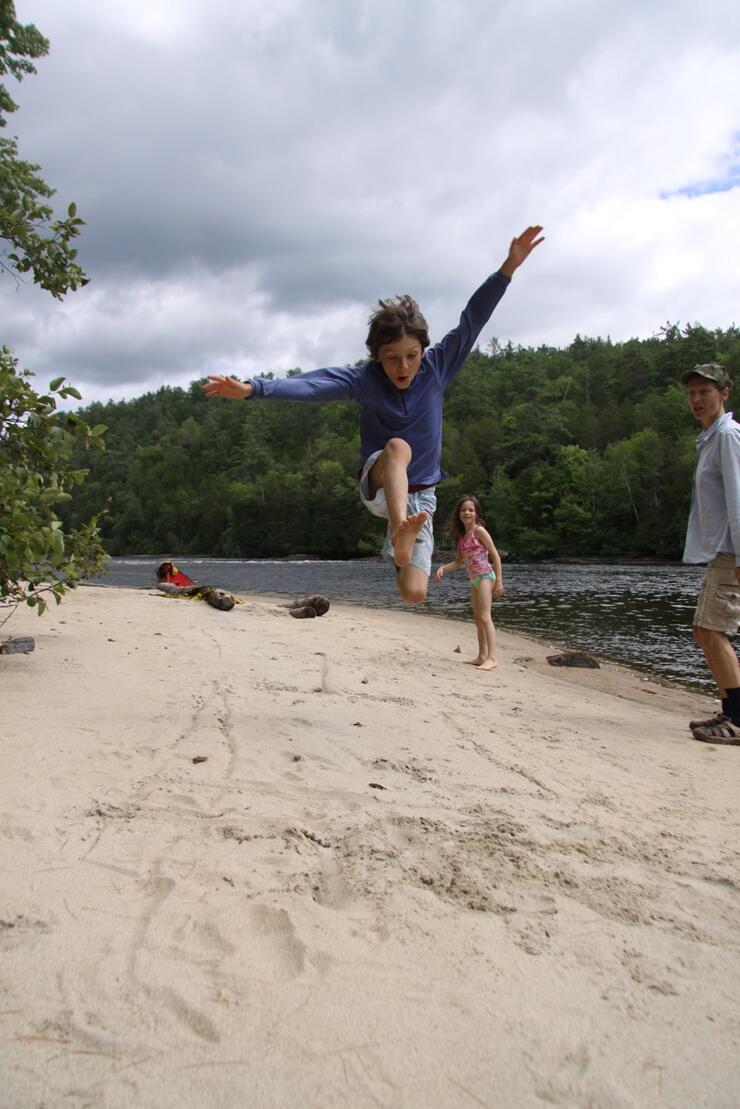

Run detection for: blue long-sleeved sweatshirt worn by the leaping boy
[[251, 272, 510, 486]]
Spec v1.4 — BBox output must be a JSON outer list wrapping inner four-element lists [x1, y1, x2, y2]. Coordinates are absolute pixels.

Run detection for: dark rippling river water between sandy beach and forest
[[93, 557, 713, 691]]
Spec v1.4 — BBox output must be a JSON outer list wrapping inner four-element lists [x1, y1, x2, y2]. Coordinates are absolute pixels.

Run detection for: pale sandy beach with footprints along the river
[[0, 588, 740, 1109]]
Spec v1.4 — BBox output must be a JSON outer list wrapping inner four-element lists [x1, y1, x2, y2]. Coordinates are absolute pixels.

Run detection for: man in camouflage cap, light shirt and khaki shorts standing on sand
[[681, 363, 740, 746]]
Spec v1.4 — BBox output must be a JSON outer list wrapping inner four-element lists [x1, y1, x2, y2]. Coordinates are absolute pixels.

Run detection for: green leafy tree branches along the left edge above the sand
[[0, 0, 105, 613]]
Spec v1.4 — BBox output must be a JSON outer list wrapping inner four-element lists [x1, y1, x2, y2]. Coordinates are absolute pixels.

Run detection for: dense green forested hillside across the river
[[60, 325, 740, 559]]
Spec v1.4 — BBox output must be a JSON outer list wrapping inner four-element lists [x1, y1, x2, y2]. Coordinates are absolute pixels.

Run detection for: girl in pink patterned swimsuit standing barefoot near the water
[[434, 495, 504, 670]]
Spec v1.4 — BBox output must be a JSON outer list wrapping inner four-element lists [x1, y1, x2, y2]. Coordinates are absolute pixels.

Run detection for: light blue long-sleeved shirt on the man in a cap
[[683, 413, 740, 566]]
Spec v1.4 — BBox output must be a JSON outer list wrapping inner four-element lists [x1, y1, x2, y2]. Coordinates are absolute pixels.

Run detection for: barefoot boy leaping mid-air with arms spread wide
[[203, 226, 544, 604]]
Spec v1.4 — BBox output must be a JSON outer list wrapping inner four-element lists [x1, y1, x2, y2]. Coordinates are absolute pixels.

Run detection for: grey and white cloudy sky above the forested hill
[[0, 0, 740, 401]]
